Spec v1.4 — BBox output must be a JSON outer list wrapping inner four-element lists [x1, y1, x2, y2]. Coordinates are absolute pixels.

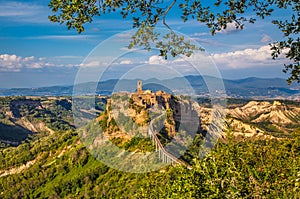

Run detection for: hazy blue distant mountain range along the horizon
[[0, 76, 300, 100]]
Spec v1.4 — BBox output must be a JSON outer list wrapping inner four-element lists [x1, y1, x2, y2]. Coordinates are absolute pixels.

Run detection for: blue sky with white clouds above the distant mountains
[[0, 0, 296, 88]]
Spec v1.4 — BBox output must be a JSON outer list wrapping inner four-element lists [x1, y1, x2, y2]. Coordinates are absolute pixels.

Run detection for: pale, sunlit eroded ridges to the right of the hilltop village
[[197, 101, 300, 139]]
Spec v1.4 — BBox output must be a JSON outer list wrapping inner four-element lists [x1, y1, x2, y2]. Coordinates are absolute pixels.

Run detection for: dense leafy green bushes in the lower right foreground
[[137, 135, 300, 198]]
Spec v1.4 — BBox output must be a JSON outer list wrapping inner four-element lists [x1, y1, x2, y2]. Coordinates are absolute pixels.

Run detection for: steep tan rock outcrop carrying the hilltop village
[[98, 91, 201, 146]]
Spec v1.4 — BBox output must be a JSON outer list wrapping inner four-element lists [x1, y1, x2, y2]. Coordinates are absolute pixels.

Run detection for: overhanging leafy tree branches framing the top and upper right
[[49, 0, 300, 84]]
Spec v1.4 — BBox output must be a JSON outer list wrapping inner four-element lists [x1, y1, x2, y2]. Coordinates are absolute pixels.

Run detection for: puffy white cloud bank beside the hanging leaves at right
[[212, 45, 287, 68]]
